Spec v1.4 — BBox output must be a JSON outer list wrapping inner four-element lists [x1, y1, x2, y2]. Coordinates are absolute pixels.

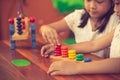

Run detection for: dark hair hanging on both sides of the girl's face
[[78, 0, 114, 33]]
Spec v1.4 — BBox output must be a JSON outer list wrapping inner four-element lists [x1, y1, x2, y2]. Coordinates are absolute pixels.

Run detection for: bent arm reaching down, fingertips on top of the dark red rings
[[39, 19, 69, 44]]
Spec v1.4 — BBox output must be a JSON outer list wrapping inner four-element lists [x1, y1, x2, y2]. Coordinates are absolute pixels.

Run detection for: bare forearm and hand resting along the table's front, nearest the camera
[[48, 58, 120, 75]]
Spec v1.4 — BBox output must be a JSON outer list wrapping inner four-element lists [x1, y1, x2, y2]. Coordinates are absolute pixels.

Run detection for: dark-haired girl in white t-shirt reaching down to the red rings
[[40, 0, 119, 57]]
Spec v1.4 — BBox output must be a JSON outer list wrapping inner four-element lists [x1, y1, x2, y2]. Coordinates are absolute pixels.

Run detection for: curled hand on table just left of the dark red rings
[[41, 44, 55, 57]]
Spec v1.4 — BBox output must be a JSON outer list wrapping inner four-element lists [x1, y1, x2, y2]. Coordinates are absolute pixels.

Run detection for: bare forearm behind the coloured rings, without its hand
[[68, 30, 114, 53]]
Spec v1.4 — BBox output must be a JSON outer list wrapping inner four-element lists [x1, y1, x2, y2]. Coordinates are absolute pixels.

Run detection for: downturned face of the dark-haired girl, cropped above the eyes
[[84, 0, 112, 19]]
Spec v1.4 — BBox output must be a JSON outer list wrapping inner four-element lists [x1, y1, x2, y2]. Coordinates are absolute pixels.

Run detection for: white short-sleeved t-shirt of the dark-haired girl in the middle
[[64, 9, 119, 57]]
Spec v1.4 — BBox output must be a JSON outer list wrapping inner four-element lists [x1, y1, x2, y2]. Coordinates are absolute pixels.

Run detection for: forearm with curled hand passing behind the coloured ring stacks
[[41, 31, 114, 57]]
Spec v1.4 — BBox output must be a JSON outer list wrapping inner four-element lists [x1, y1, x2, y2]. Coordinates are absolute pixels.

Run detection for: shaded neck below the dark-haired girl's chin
[[90, 18, 104, 31]]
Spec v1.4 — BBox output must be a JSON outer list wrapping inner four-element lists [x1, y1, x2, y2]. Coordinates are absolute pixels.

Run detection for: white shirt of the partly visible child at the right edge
[[110, 24, 120, 58]]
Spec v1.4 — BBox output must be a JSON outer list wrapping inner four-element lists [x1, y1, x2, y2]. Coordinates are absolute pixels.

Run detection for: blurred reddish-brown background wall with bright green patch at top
[[0, 0, 84, 43]]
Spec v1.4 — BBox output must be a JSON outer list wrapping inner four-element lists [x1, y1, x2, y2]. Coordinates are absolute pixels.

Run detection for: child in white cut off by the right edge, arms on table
[[48, 0, 120, 75]]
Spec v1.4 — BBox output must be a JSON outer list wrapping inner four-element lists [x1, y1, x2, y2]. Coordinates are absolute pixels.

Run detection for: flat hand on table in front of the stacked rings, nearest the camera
[[47, 61, 78, 75]]
